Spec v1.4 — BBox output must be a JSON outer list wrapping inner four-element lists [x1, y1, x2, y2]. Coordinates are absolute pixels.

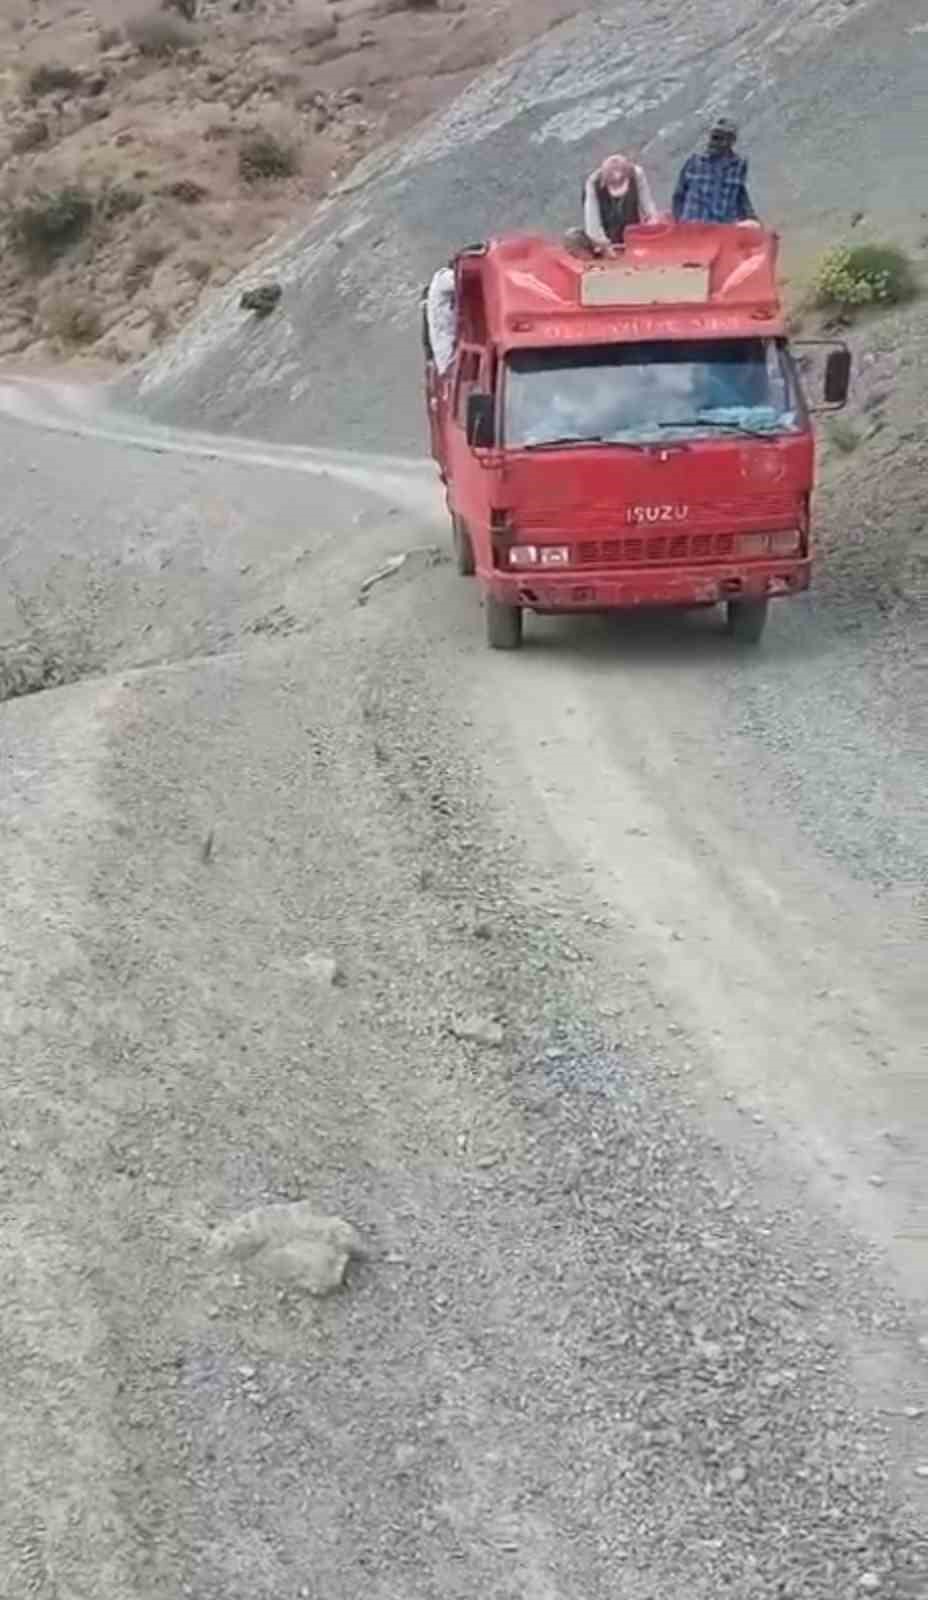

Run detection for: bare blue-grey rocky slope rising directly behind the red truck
[[123, 0, 928, 603]]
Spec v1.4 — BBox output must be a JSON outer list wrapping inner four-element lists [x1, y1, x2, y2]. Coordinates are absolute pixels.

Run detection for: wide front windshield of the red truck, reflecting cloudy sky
[[504, 339, 803, 448]]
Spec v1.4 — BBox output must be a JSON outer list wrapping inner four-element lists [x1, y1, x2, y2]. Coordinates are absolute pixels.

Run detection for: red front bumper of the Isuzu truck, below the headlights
[[480, 560, 811, 613]]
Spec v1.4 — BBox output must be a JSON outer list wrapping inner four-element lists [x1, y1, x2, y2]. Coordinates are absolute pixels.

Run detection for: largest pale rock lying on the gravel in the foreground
[[211, 1200, 362, 1296]]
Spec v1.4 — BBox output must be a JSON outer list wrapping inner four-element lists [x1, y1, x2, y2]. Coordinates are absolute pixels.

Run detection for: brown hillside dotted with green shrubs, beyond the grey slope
[[0, 0, 581, 363]]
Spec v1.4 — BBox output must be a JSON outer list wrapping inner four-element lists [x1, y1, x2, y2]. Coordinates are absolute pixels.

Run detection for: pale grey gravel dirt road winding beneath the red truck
[[0, 386, 928, 1600]]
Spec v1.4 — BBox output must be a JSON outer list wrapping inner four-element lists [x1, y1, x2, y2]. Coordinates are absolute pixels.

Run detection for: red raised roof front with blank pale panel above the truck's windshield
[[458, 222, 786, 349]]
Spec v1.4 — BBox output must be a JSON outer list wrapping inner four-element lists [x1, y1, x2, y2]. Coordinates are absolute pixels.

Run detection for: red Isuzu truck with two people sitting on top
[[426, 222, 851, 650]]
